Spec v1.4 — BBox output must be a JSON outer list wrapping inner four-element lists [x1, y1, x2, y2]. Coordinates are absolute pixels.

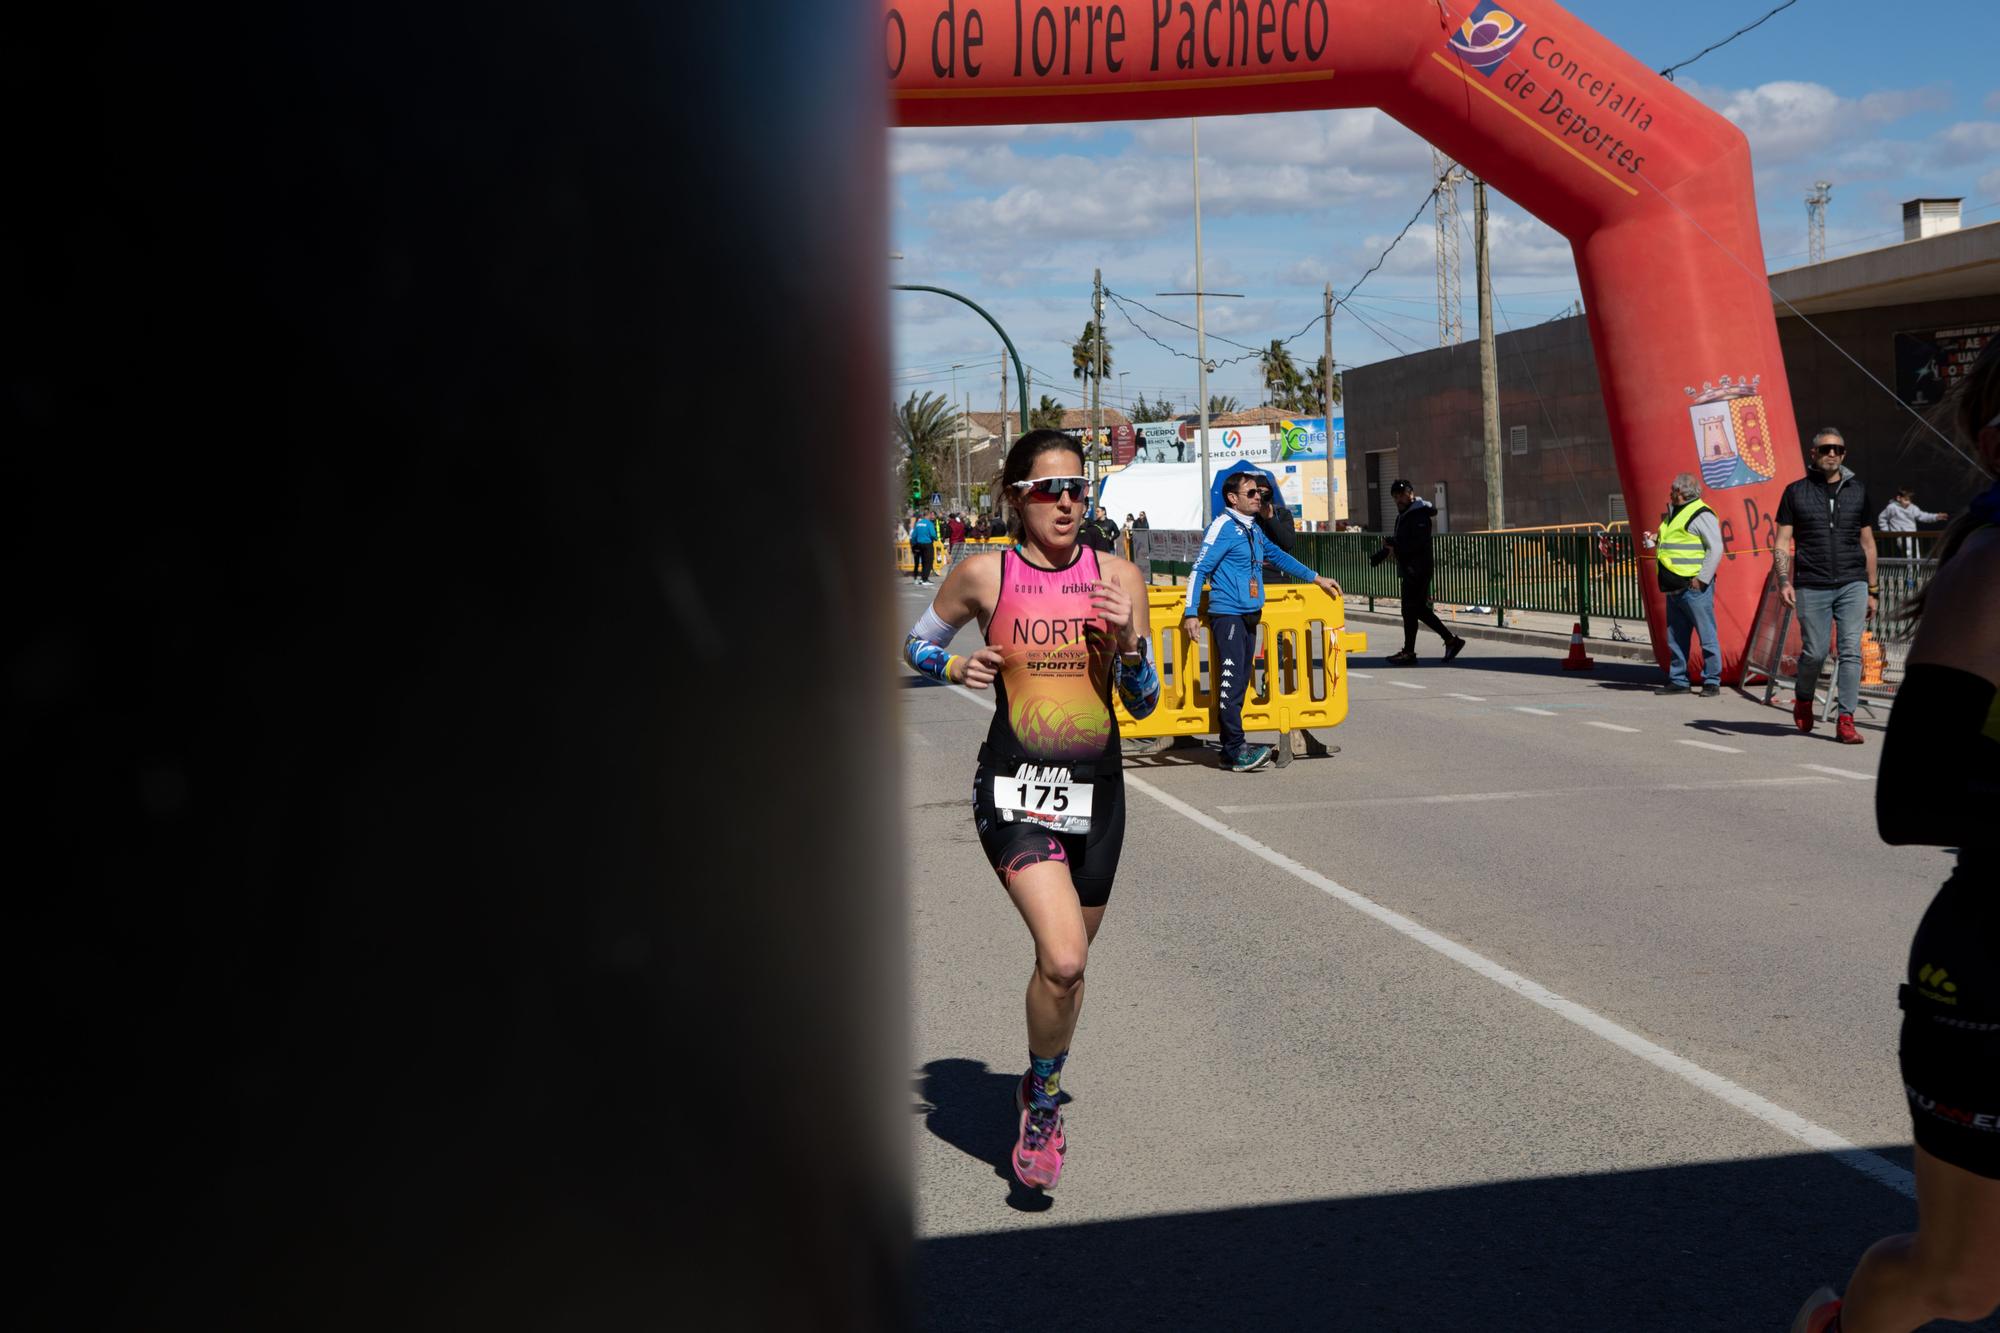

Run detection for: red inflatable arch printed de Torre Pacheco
[[884, 0, 1804, 681]]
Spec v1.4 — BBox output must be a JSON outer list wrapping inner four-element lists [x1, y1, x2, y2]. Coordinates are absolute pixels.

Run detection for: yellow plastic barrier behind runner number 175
[[1112, 582, 1368, 745]]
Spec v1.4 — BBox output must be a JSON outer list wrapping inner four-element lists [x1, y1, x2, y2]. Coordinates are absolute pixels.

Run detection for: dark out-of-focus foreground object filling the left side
[[0, 4, 908, 1329]]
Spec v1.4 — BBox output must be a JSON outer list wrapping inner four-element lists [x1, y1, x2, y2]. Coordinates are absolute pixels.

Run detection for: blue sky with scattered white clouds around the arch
[[890, 0, 2000, 420]]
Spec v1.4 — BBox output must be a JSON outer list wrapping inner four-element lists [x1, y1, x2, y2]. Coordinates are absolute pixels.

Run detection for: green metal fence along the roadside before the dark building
[[1150, 530, 1650, 634]]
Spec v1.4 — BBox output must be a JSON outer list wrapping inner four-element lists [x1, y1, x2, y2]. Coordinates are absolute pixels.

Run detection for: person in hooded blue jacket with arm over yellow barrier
[[1180, 472, 1340, 773]]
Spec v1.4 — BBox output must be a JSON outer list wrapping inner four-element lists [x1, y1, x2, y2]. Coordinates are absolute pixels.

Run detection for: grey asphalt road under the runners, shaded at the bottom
[[898, 584, 2000, 1333]]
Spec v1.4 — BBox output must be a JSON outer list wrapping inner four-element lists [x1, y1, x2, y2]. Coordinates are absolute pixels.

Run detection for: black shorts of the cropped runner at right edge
[[1900, 859, 2000, 1181]]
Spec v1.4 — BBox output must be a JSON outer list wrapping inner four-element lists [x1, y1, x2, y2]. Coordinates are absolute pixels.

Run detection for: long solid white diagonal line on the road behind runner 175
[[946, 685, 1916, 1199]]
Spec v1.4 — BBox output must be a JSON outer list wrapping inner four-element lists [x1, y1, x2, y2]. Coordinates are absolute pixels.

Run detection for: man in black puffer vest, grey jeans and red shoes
[[1772, 426, 1878, 745]]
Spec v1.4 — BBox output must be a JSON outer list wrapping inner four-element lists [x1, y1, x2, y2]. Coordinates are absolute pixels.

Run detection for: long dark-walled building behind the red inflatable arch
[[1342, 200, 2000, 532]]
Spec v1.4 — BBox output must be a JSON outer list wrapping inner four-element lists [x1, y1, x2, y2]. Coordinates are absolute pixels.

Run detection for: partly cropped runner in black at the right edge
[[1792, 342, 2000, 1333]]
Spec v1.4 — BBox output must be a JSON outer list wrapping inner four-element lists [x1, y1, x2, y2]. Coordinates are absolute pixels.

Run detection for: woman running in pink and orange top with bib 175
[[904, 430, 1160, 1189]]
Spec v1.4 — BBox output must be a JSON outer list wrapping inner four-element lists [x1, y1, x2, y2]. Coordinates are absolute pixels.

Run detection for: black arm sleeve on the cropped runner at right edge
[[1876, 662, 2000, 849]]
